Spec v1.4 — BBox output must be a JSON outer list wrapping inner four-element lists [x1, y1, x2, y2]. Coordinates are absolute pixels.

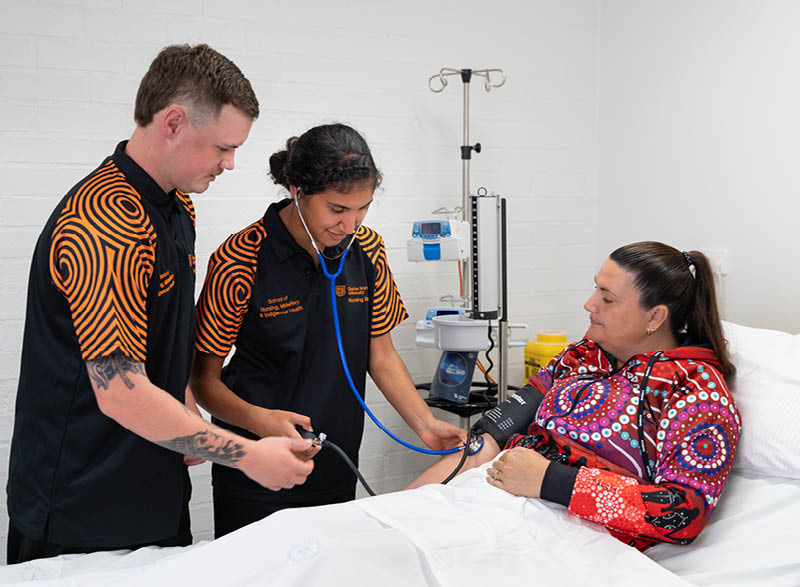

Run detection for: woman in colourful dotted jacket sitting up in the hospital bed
[[411, 242, 741, 549]]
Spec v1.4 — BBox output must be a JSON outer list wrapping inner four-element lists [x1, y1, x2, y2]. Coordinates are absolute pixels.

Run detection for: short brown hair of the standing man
[[133, 45, 258, 126]]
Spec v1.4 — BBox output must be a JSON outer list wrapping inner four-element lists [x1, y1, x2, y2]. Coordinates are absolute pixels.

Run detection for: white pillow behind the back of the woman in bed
[[723, 322, 800, 479]]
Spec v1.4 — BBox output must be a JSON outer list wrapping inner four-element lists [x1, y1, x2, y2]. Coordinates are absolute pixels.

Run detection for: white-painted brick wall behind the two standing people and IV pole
[[0, 0, 596, 556]]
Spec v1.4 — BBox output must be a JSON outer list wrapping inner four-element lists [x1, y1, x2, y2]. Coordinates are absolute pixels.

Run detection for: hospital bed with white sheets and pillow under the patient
[[0, 324, 800, 587]]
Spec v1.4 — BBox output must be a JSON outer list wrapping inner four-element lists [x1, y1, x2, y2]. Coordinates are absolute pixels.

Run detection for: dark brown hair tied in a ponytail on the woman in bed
[[609, 241, 736, 379]]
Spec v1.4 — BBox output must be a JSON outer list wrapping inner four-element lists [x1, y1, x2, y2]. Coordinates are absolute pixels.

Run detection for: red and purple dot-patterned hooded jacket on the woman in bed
[[506, 339, 741, 550]]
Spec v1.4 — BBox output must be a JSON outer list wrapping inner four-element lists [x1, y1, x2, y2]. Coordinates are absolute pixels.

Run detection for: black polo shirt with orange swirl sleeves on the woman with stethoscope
[[196, 199, 408, 503]]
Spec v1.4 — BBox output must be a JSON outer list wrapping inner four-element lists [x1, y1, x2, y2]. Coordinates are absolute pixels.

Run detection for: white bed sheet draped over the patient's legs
[[0, 470, 690, 587]]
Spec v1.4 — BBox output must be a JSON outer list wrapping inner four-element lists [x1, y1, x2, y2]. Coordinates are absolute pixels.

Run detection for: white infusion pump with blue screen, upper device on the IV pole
[[406, 220, 469, 261]]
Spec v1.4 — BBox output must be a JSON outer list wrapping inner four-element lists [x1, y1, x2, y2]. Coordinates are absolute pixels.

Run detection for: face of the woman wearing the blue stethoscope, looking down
[[292, 182, 374, 247]]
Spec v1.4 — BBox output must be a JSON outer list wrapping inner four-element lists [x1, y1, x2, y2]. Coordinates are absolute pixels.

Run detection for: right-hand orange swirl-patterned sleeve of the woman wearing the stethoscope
[[356, 226, 408, 337]]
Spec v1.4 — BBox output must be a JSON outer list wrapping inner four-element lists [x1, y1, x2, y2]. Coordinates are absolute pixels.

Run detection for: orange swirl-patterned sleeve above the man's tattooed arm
[[50, 161, 156, 362]]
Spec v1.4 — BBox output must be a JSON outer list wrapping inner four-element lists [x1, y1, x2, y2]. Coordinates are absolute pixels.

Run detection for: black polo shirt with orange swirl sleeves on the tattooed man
[[7, 142, 195, 547]]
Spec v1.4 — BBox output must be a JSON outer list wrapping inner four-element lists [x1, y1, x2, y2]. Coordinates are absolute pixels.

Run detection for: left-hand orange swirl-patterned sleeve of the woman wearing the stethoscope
[[195, 220, 267, 357]]
